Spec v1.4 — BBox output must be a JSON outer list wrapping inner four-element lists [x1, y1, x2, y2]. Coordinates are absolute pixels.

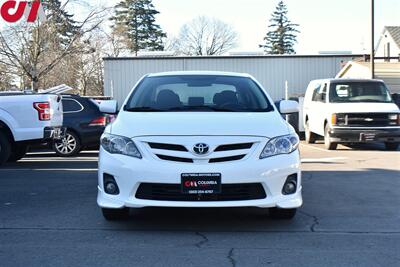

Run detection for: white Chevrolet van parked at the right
[[303, 79, 400, 150]]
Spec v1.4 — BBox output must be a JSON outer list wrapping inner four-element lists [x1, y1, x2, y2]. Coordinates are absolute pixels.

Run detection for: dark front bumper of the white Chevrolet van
[[329, 128, 400, 143]]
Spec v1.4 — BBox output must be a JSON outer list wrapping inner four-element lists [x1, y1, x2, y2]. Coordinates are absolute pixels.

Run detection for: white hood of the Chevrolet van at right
[[330, 103, 400, 113]]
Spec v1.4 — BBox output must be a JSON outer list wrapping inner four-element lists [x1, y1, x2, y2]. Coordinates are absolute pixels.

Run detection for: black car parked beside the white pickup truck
[[52, 95, 108, 157]]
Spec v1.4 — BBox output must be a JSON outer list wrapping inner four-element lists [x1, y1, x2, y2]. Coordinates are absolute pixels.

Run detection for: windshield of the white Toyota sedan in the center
[[124, 75, 273, 112]]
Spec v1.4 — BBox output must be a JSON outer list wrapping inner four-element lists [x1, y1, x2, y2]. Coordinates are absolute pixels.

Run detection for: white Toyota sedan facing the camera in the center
[[97, 72, 303, 220]]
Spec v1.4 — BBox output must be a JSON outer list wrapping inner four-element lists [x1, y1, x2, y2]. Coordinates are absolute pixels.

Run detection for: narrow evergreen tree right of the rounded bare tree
[[260, 1, 299, 55]]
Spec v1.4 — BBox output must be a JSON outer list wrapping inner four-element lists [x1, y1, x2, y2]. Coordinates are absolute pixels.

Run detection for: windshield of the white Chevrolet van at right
[[329, 82, 392, 103]]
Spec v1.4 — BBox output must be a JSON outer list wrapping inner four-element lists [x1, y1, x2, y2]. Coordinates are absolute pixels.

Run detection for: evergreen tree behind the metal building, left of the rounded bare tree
[[111, 0, 167, 55]]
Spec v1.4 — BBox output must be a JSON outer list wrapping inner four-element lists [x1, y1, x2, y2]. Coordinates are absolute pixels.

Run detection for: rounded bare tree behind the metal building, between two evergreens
[[174, 16, 238, 55]]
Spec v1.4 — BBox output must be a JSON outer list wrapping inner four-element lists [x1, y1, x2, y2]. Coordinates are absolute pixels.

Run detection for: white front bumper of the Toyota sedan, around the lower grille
[[97, 148, 303, 209]]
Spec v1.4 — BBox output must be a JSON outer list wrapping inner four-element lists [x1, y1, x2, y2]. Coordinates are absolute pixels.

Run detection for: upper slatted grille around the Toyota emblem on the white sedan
[[145, 142, 255, 163]]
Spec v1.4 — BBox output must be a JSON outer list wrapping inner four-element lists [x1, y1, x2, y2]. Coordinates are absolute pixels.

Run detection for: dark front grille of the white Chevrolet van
[[337, 113, 393, 127]]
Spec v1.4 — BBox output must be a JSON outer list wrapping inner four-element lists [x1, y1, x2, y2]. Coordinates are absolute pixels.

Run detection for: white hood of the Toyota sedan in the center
[[108, 112, 290, 138]]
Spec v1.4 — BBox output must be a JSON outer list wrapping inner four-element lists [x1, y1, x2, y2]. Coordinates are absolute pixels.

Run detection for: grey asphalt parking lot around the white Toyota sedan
[[0, 144, 400, 266]]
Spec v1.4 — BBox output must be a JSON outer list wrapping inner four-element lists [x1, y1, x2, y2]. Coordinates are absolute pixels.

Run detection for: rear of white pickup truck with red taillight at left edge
[[0, 93, 63, 166]]
